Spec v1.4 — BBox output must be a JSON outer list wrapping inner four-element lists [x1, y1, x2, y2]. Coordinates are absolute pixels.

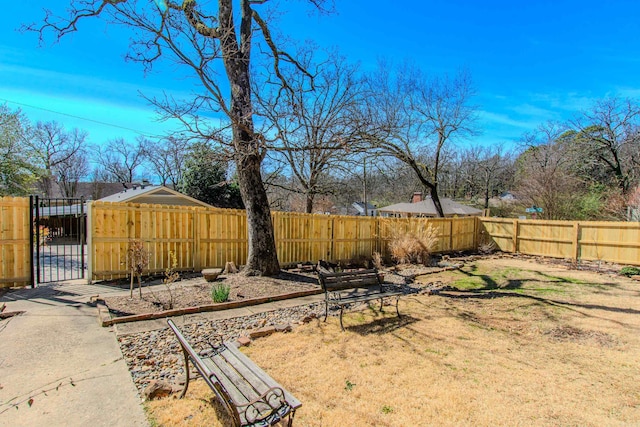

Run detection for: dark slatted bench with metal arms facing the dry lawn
[[318, 268, 405, 331]]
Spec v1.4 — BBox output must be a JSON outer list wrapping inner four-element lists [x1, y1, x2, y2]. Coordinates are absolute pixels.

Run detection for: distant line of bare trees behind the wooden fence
[[0, 91, 640, 220]]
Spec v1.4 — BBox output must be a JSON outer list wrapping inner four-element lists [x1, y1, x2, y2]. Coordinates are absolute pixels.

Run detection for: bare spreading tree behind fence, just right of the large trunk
[[255, 54, 361, 213]]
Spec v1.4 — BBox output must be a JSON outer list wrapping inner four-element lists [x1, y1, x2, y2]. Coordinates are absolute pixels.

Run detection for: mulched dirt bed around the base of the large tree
[[105, 272, 319, 317]]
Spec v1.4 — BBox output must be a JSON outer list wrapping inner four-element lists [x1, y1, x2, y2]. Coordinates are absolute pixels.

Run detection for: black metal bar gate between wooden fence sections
[[30, 196, 86, 286]]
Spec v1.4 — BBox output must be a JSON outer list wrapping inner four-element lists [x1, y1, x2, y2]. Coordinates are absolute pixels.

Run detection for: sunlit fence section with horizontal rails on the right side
[[479, 218, 640, 265]]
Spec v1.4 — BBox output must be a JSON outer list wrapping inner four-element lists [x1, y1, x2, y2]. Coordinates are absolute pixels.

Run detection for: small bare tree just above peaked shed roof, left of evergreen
[[96, 137, 144, 183]]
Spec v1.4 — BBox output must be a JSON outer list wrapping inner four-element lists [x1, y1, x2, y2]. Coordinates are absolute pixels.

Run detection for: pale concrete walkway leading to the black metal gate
[[0, 282, 148, 427]]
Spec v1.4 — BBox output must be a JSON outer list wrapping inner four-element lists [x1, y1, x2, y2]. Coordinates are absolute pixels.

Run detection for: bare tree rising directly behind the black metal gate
[[29, 122, 87, 197]]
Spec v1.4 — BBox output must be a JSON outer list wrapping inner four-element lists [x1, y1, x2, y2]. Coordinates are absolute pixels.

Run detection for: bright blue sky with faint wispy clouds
[[0, 0, 640, 150]]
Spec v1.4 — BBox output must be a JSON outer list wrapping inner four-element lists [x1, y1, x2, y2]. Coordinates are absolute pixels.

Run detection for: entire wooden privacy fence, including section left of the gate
[[0, 197, 640, 287]]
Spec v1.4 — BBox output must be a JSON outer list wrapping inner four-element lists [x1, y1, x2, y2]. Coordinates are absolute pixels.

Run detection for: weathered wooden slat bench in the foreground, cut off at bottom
[[168, 320, 302, 427]]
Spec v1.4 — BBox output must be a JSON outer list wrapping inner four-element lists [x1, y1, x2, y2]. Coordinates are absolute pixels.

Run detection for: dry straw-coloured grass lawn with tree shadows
[[148, 259, 640, 427]]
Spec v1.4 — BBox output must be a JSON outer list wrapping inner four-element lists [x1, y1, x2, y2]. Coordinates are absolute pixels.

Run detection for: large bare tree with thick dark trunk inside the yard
[[31, 0, 324, 275]]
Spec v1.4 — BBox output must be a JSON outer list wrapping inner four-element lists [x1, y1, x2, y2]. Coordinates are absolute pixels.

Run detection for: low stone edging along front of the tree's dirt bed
[[96, 289, 324, 327]]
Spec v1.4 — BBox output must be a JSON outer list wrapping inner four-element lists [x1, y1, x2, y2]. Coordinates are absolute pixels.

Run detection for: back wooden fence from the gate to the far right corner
[[87, 202, 477, 280]]
